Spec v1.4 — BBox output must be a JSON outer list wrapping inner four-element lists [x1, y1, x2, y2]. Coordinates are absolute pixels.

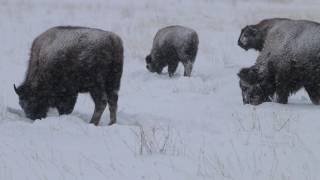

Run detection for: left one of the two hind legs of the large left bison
[[90, 90, 107, 126]]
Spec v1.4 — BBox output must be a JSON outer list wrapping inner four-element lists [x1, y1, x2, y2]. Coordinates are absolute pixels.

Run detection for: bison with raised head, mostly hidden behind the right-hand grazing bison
[[238, 18, 290, 51]]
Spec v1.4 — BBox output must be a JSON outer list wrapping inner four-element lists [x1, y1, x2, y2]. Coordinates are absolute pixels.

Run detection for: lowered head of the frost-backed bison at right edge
[[238, 67, 275, 105]]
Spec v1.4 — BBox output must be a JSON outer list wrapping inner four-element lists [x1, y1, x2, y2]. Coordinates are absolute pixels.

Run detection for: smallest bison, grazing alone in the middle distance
[[146, 26, 199, 77]]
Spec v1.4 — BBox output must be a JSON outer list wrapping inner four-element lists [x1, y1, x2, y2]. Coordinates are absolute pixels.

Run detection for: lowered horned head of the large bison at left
[[14, 84, 49, 120]]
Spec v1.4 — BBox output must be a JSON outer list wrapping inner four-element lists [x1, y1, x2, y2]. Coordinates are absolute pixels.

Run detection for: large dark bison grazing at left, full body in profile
[[14, 26, 123, 125]]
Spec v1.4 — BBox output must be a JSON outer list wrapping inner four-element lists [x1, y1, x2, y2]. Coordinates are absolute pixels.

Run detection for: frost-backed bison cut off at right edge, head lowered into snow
[[238, 20, 320, 105]]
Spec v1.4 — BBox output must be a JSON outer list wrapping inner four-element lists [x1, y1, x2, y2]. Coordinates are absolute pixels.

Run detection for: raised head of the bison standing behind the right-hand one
[[238, 26, 264, 51]]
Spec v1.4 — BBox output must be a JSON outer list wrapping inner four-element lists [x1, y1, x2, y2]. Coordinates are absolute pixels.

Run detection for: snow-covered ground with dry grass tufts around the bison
[[0, 0, 320, 180]]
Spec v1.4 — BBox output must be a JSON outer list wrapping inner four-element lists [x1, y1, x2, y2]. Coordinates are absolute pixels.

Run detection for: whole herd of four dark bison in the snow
[[14, 18, 320, 125]]
